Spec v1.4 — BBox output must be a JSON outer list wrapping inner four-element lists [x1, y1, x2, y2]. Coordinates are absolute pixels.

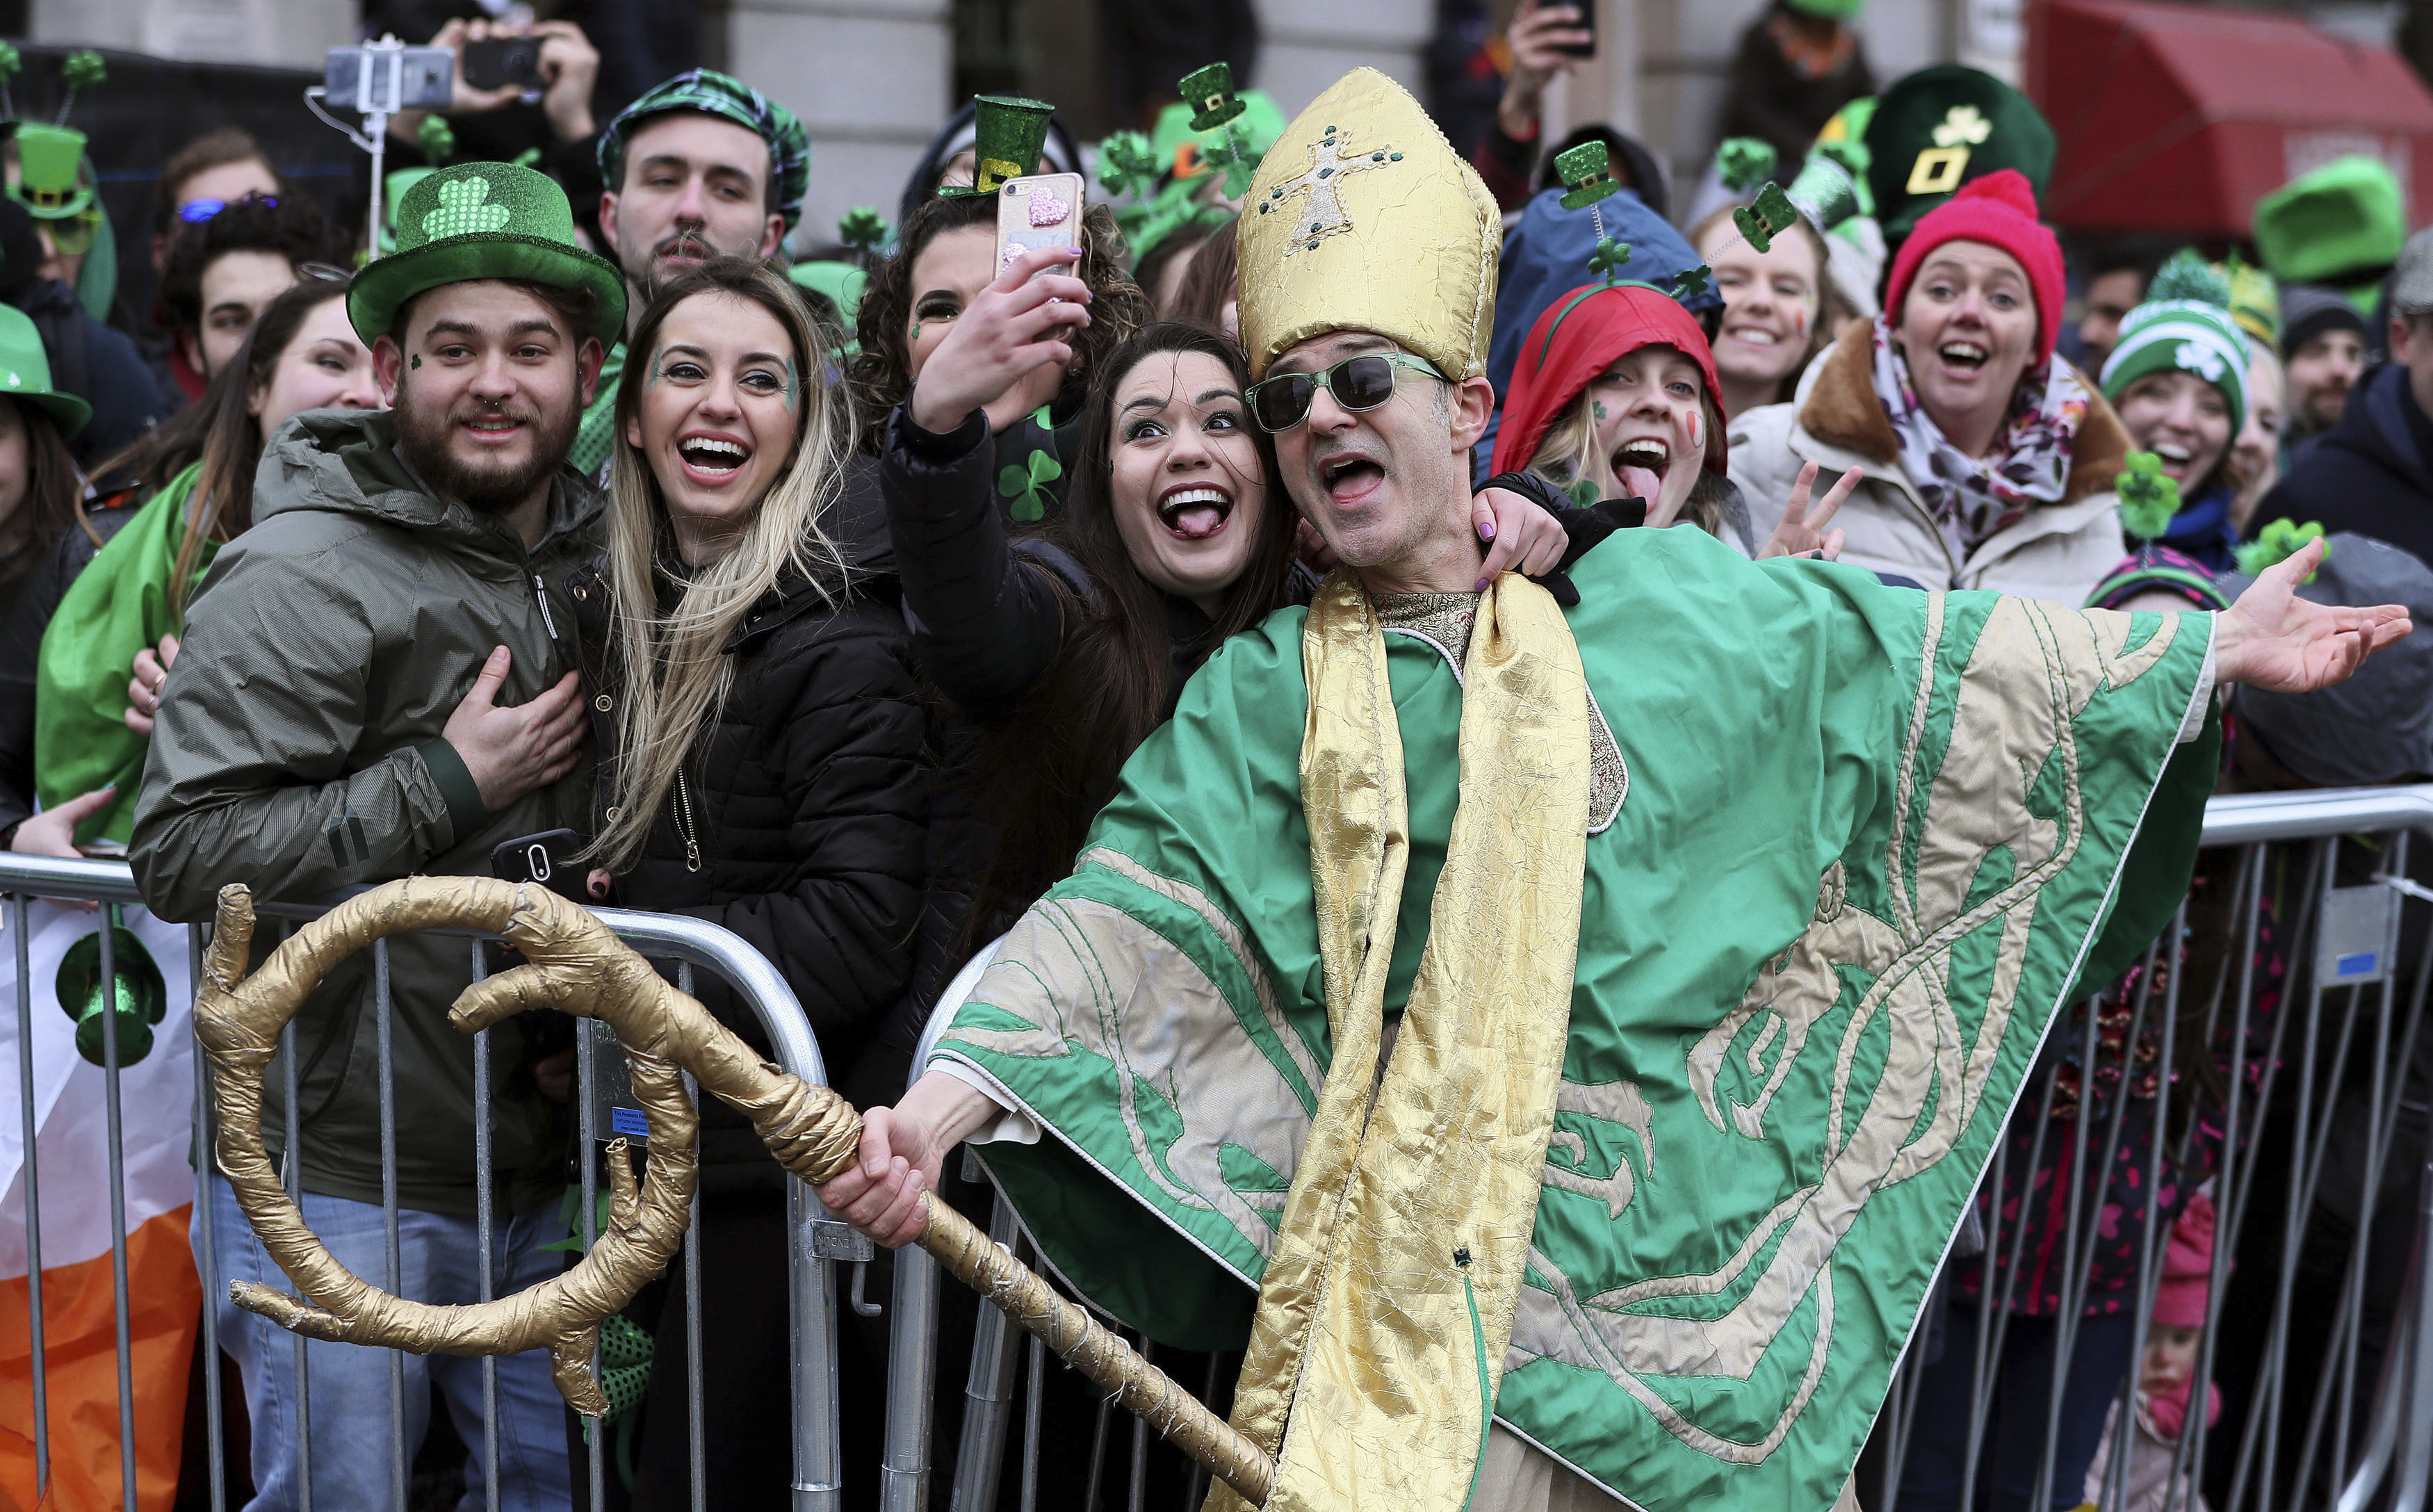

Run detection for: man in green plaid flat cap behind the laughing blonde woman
[[572, 68, 811, 482]]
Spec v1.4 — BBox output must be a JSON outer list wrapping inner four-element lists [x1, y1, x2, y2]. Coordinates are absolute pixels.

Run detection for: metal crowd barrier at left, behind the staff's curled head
[[0, 852, 869, 1512]]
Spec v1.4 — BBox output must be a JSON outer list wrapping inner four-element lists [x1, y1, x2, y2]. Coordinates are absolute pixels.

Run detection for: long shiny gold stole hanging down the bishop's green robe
[[1207, 570, 1589, 1512]]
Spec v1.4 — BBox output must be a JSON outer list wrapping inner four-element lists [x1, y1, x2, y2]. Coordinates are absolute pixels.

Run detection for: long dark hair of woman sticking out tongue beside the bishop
[[966, 321, 1294, 929]]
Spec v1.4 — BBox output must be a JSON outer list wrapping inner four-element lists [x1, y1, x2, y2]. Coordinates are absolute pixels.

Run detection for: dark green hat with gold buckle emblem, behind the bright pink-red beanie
[[1866, 63, 2053, 243]]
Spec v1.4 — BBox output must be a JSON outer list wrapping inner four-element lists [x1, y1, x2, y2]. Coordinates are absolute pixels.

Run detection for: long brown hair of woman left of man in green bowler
[[88, 277, 345, 619]]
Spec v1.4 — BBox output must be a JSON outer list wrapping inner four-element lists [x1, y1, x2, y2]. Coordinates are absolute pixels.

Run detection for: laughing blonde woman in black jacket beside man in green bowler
[[567, 258, 929, 1507]]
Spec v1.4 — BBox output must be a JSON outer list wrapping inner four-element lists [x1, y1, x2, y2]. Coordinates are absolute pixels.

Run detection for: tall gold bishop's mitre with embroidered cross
[[1239, 68, 1504, 380]]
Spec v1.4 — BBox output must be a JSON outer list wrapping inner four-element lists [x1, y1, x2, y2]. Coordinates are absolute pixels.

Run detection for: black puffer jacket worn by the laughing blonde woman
[[567, 540, 932, 1188]]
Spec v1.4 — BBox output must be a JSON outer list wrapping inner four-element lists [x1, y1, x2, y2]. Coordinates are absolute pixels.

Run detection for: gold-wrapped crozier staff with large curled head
[[195, 877, 1275, 1504]]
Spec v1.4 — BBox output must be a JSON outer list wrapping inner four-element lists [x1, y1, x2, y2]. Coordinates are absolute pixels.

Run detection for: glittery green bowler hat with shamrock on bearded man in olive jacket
[[345, 163, 626, 346]]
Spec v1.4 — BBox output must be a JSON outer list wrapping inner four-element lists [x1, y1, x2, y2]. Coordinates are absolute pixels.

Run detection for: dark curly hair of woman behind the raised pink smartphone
[[847, 195, 1148, 450]]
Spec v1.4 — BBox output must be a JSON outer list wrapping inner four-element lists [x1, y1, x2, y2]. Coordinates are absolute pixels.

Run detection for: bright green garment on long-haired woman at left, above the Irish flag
[[34, 462, 219, 845]]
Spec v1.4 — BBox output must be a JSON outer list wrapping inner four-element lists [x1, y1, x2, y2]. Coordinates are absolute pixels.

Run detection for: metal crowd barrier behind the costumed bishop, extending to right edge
[[881, 784, 2433, 1512]]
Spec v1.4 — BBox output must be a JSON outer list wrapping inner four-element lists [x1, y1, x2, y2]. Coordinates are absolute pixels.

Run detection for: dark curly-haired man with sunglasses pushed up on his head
[[161, 195, 343, 402]]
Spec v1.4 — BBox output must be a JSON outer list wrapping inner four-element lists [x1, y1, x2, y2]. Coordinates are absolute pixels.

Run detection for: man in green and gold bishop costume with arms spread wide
[[822, 68, 2407, 1512]]
